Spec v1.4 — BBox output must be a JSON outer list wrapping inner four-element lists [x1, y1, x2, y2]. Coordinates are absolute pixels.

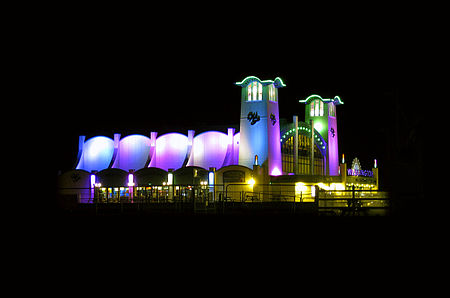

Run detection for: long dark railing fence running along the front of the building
[[58, 184, 389, 215]]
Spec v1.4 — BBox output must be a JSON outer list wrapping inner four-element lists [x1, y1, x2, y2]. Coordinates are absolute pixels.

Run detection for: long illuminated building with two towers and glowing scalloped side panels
[[55, 76, 378, 208]]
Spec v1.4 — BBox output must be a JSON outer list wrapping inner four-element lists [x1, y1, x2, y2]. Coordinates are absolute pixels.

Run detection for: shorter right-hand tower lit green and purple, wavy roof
[[299, 94, 344, 176]]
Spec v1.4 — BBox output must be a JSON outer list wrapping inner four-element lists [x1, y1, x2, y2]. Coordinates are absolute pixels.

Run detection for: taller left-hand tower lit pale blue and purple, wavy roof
[[235, 76, 286, 176]]
